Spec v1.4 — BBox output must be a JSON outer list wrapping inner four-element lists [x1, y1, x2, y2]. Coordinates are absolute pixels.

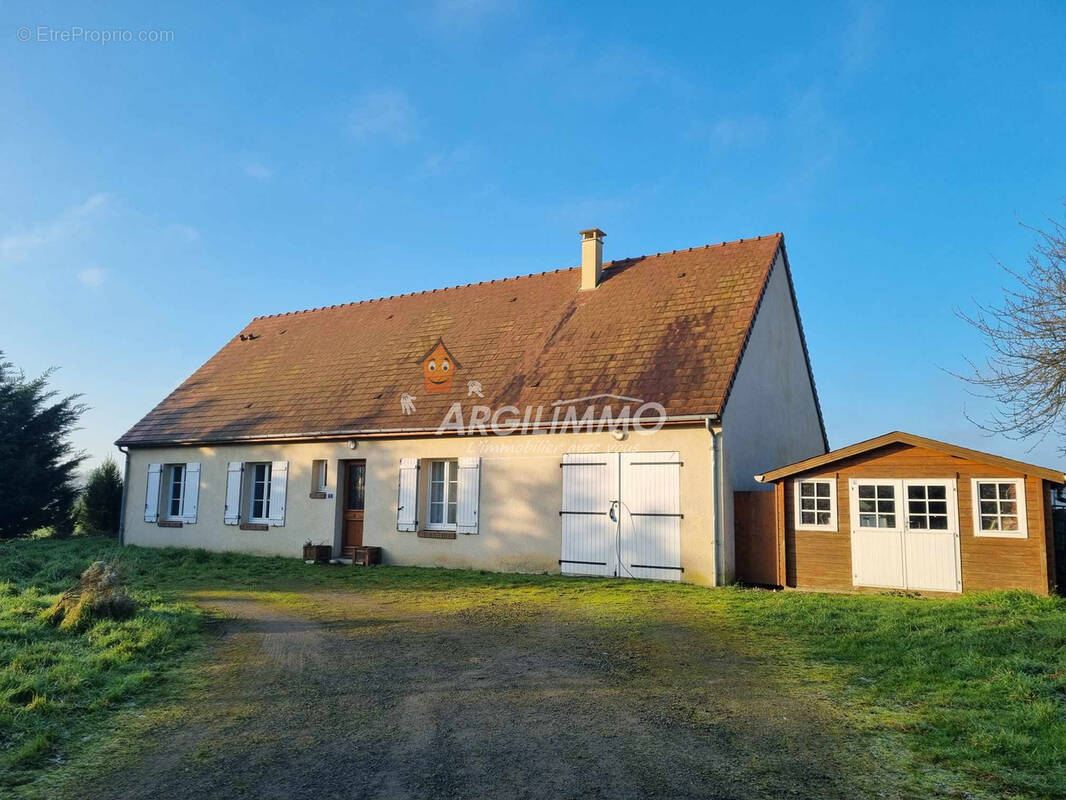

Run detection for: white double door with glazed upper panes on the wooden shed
[[847, 478, 963, 592]]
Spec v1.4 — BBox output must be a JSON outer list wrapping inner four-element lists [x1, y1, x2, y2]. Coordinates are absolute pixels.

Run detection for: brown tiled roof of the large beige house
[[118, 234, 801, 445]]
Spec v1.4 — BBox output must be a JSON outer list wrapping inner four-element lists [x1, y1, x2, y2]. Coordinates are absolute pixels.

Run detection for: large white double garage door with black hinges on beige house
[[559, 452, 683, 580]]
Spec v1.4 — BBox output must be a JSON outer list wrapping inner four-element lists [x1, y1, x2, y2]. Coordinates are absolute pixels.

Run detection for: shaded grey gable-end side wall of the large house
[[722, 253, 825, 578]]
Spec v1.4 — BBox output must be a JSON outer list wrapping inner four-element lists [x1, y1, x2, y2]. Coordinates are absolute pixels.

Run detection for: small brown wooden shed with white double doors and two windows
[[750, 431, 1066, 594]]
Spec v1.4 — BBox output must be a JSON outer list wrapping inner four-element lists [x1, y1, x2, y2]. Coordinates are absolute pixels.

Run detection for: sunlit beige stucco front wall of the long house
[[125, 426, 714, 585]]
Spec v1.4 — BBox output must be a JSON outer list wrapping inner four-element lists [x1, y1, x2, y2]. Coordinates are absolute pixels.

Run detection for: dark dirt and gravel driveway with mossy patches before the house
[[75, 593, 901, 800]]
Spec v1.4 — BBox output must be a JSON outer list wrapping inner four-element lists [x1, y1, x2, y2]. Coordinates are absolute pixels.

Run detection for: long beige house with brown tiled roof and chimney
[[117, 228, 827, 585]]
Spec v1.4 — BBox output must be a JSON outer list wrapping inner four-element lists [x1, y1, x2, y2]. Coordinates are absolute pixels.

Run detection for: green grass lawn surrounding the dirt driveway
[[6, 538, 1066, 797]]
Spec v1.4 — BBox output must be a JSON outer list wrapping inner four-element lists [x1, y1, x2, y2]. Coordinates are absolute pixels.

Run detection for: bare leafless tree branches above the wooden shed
[[959, 213, 1066, 452]]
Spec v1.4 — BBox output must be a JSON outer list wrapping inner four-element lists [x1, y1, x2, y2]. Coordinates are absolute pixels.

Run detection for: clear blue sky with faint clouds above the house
[[0, 0, 1066, 467]]
